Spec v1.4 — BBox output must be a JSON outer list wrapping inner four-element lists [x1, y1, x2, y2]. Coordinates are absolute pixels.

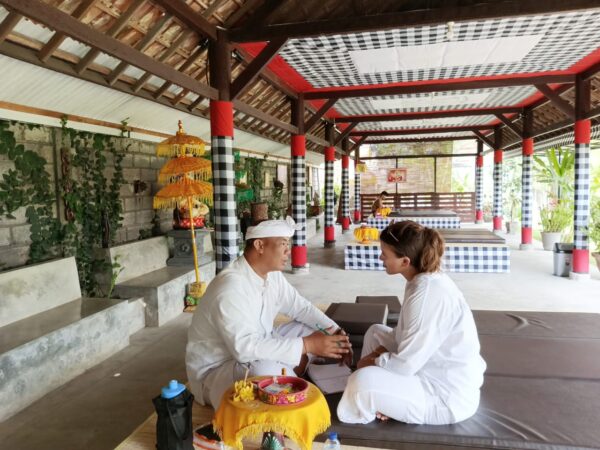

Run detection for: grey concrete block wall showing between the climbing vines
[[0, 119, 172, 270]]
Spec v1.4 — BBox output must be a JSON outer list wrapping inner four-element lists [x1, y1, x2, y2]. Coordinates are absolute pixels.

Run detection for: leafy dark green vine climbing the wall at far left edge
[[0, 121, 64, 263]]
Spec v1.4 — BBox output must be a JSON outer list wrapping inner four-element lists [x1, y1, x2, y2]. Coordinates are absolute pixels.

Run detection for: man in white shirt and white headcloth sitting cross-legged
[[186, 218, 351, 409]]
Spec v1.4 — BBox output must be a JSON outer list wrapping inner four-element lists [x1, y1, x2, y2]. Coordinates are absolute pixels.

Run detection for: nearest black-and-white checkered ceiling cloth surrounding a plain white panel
[[280, 9, 600, 88]]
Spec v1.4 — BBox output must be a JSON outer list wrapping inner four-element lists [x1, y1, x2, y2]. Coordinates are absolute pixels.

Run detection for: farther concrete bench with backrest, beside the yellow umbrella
[[105, 236, 216, 327]]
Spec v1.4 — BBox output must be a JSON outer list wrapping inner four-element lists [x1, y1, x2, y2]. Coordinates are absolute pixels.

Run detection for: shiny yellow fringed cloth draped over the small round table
[[213, 377, 331, 450]]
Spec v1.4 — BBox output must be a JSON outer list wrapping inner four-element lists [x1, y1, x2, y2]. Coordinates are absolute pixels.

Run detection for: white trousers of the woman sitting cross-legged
[[337, 325, 454, 425]]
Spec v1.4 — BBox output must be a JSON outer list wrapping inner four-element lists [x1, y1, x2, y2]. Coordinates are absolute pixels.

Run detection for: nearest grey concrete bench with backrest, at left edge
[[0, 257, 135, 422]]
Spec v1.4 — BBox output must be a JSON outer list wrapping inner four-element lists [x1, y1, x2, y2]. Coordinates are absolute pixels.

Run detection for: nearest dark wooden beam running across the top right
[[230, 0, 599, 42]]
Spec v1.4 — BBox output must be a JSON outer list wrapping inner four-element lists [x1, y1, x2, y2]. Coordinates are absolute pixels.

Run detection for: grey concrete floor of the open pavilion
[[0, 223, 600, 450]]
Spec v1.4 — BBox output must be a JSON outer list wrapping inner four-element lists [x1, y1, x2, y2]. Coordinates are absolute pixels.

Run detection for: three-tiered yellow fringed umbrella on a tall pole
[[154, 120, 213, 299]]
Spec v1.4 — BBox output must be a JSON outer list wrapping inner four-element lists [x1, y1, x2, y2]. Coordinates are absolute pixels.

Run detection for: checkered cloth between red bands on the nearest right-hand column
[[574, 144, 590, 250]]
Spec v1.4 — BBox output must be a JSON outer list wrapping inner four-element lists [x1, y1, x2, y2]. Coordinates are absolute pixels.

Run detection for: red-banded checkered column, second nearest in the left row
[[292, 135, 307, 267]]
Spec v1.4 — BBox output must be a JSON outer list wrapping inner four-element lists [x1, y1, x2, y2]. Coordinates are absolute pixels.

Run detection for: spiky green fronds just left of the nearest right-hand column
[[533, 147, 575, 200]]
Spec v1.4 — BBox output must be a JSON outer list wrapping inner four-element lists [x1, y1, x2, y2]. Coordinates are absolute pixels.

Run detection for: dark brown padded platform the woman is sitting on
[[319, 311, 600, 450]]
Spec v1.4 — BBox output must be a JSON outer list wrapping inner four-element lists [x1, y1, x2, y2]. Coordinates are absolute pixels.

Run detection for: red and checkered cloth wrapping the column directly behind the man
[[210, 100, 238, 272]]
